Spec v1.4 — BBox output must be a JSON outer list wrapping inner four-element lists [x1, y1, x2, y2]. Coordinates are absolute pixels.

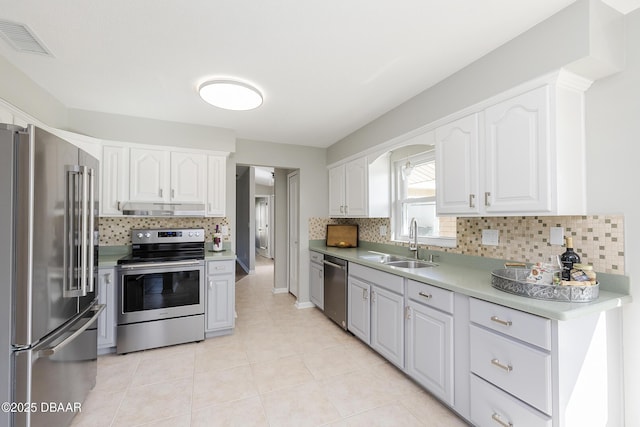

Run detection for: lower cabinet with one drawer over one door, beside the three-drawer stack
[[406, 280, 454, 405]]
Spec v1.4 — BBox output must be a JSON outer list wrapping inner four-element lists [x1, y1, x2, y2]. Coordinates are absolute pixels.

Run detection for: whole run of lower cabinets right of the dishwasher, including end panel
[[338, 262, 624, 427]]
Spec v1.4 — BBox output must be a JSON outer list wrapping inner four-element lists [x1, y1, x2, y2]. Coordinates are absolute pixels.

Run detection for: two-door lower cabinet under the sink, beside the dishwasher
[[347, 264, 404, 369]]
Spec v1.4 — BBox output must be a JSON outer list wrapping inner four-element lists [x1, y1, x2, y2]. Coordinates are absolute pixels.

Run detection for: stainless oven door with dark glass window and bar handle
[[118, 260, 204, 325]]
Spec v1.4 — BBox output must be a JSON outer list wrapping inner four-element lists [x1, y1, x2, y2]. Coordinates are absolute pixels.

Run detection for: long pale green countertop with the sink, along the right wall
[[309, 240, 631, 320]]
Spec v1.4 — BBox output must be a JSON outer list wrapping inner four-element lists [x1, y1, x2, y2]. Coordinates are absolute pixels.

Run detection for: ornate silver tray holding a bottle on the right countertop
[[491, 268, 600, 302]]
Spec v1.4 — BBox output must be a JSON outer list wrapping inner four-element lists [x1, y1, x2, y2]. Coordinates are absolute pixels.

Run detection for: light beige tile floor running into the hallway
[[73, 261, 466, 427]]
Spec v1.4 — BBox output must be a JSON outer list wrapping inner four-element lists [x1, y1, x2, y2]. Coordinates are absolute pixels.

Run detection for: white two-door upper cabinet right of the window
[[436, 72, 590, 216]]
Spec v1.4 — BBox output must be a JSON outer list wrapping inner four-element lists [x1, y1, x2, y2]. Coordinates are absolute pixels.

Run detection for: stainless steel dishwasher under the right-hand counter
[[322, 255, 348, 330]]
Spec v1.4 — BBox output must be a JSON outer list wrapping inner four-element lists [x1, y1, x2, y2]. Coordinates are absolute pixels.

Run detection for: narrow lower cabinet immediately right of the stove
[[205, 260, 235, 332]]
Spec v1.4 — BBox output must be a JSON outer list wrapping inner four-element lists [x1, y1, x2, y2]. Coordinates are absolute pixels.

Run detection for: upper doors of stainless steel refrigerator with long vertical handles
[[13, 126, 97, 347]]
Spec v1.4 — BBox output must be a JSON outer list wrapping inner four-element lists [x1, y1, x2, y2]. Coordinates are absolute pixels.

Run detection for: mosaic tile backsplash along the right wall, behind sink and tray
[[309, 215, 624, 274]]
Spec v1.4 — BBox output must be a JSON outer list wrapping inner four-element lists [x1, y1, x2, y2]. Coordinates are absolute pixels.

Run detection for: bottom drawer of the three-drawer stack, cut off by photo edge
[[470, 374, 551, 427]]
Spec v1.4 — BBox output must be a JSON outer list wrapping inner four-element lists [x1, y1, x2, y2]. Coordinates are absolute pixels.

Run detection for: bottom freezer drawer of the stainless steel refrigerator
[[11, 305, 104, 427]]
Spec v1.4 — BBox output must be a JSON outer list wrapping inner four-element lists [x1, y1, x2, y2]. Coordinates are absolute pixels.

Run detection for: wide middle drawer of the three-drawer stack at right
[[470, 325, 551, 414]]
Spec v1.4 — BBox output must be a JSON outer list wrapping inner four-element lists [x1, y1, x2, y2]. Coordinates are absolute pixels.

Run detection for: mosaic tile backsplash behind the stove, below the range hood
[[99, 217, 231, 246]]
